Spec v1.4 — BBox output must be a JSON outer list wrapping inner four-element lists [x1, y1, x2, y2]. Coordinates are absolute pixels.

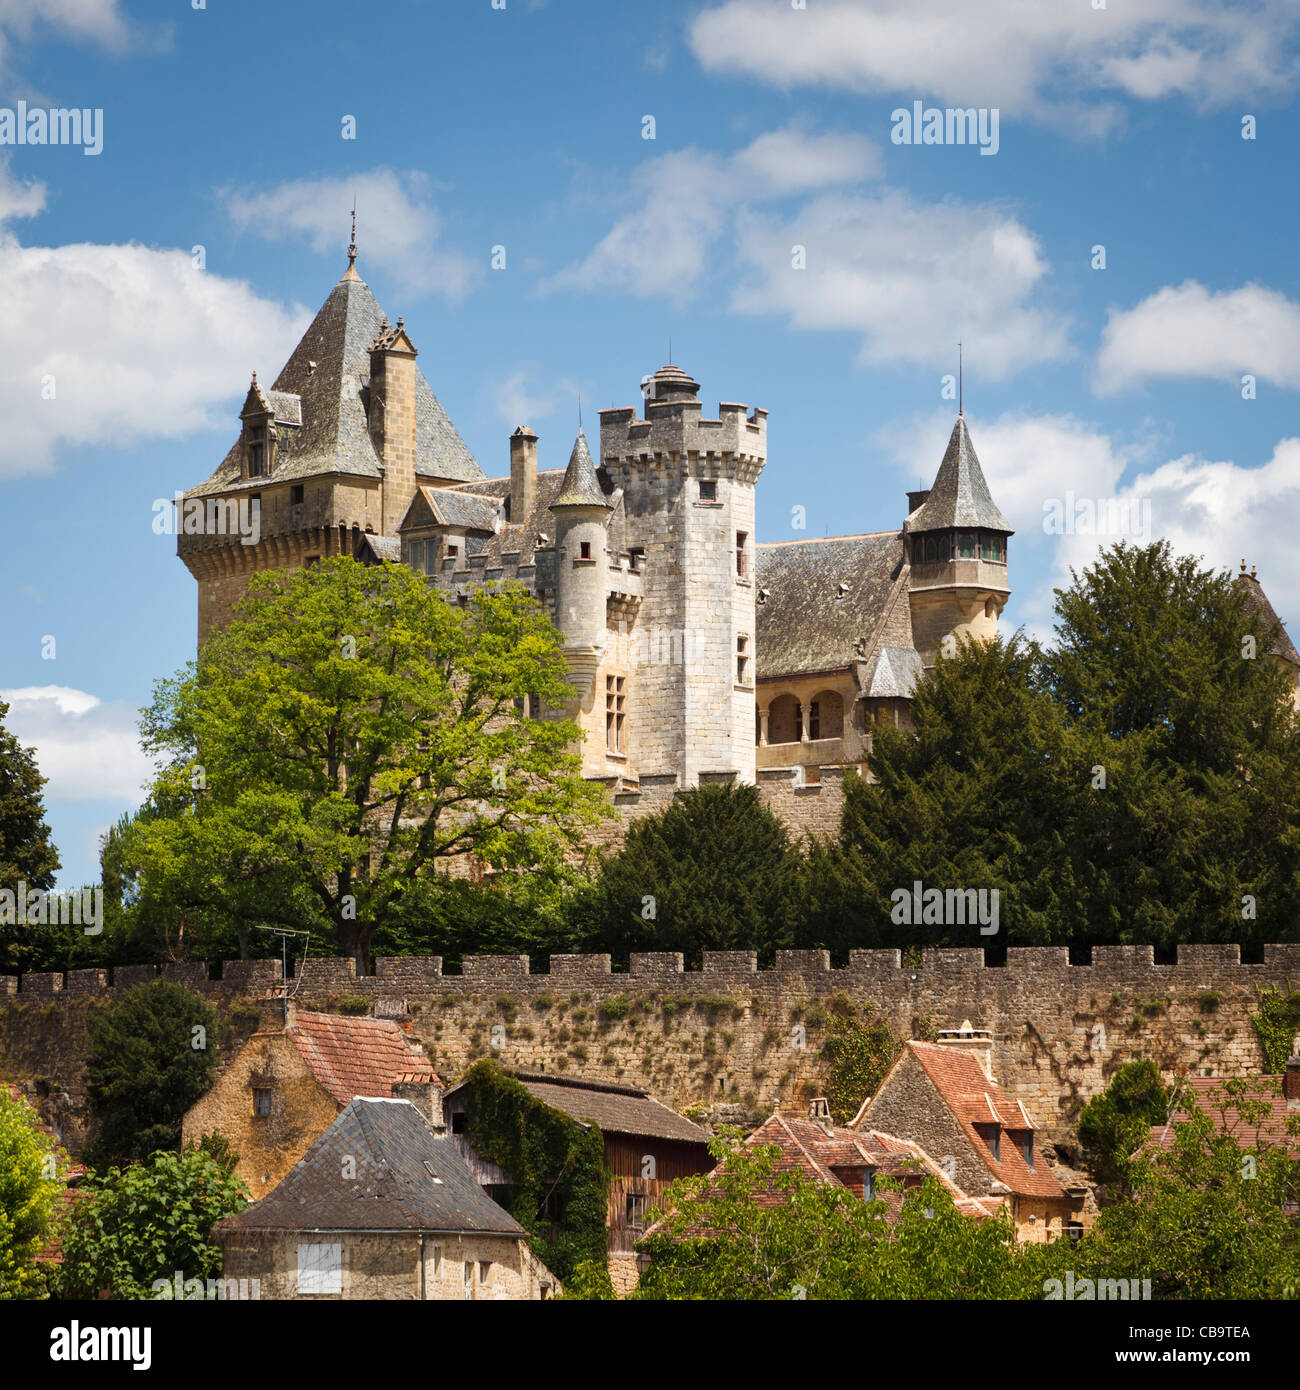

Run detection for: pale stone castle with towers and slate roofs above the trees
[[178, 236, 1012, 819]]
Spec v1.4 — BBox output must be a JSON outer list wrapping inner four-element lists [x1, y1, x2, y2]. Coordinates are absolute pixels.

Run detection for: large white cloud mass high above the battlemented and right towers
[[542, 122, 1071, 378]]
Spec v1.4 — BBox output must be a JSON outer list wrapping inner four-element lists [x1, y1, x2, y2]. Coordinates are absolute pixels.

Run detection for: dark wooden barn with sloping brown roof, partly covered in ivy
[[442, 1072, 713, 1291]]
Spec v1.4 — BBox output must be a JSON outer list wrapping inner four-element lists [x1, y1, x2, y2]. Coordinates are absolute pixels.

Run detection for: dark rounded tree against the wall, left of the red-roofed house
[[86, 980, 216, 1168]]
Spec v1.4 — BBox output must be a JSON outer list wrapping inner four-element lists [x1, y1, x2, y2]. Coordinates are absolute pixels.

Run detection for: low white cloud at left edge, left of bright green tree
[[0, 685, 153, 806]]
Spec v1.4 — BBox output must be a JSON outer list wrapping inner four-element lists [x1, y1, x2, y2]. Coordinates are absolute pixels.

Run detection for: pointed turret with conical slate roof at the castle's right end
[[902, 414, 1014, 669]]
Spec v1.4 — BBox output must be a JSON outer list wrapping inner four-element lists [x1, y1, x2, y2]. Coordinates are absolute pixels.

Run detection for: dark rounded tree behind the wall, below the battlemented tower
[[573, 784, 802, 965]]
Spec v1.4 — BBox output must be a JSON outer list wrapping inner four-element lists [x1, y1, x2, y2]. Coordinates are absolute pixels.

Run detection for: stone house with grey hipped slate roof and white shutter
[[213, 1097, 558, 1301]]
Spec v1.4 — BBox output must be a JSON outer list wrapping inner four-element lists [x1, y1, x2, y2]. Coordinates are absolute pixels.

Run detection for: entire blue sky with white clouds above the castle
[[0, 0, 1300, 885]]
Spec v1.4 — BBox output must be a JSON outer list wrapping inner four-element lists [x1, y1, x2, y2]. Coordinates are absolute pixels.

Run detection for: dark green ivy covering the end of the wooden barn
[[464, 1059, 609, 1282]]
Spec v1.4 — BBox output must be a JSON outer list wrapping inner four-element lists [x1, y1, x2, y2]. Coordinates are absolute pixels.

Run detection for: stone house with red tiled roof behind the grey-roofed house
[[181, 1001, 442, 1200]]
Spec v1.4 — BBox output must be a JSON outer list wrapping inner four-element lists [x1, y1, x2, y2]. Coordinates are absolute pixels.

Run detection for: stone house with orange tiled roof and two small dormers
[[850, 1023, 1084, 1241]]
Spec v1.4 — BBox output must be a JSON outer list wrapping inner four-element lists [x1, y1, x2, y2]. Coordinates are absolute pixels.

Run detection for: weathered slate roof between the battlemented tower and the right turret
[[755, 531, 905, 681]]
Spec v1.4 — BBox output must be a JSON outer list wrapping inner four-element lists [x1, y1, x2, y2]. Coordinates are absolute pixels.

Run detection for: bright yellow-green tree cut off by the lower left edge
[[0, 1086, 67, 1300]]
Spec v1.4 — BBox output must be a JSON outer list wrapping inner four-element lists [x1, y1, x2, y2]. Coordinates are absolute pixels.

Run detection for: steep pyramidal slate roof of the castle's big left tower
[[186, 265, 482, 496]]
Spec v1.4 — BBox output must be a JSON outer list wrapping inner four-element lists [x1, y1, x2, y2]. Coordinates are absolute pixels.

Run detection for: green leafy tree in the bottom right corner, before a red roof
[[1047, 1080, 1300, 1298]]
